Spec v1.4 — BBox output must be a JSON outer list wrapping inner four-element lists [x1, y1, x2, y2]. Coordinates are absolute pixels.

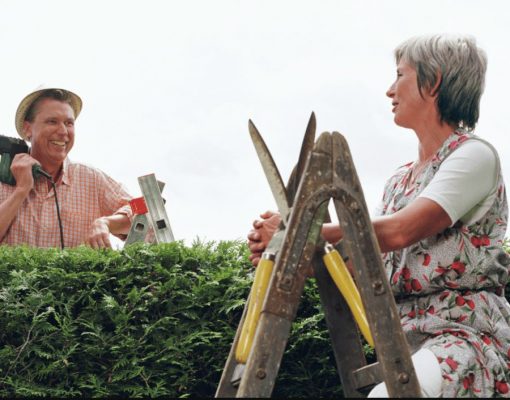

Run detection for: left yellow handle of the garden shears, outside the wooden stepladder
[[235, 253, 274, 364]]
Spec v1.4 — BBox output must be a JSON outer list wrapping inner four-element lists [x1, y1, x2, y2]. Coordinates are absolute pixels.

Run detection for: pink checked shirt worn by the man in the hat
[[0, 159, 132, 247]]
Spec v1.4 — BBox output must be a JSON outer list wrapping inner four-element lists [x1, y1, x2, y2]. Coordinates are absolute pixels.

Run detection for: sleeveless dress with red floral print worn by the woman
[[381, 130, 510, 397]]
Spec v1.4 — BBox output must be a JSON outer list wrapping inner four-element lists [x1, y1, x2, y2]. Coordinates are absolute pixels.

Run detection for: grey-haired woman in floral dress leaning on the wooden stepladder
[[248, 35, 510, 397]]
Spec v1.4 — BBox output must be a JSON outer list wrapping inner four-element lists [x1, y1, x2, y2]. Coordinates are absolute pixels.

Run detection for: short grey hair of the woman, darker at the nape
[[395, 35, 487, 130]]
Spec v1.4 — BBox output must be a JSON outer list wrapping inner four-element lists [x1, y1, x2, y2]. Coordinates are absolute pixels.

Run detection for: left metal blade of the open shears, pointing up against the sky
[[248, 120, 289, 221]]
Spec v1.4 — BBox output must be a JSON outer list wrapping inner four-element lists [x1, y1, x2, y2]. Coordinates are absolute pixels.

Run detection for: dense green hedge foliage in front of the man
[[0, 242, 342, 398]]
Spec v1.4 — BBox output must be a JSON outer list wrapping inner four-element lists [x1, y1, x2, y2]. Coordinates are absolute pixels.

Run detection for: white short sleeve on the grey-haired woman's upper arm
[[419, 140, 498, 225]]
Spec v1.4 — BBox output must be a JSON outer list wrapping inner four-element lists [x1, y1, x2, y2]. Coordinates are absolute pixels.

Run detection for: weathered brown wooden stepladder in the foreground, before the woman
[[216, 124, 420, 397]]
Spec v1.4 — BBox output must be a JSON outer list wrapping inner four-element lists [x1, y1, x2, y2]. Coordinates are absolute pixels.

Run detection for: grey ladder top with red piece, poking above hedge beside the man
[[124, 174, 174, 245]]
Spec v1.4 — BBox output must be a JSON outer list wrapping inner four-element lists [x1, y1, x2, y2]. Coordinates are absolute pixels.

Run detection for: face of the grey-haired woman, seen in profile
[[386, 60, 435, 129]]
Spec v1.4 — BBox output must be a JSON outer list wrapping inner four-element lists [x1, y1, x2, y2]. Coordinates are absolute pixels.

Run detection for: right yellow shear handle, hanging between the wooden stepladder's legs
[[323, 244, 374, 347]]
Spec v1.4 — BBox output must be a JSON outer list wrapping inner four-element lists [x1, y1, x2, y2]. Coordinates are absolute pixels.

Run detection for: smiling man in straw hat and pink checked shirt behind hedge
[[0, 88, 132, 248]]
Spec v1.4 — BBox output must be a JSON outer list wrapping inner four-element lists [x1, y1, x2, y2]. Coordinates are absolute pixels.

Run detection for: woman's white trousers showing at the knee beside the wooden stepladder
[[368, 349, 443, 398]]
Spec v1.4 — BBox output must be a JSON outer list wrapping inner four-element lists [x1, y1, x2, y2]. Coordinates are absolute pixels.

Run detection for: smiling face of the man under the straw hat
[[23, 98, 74, 168]]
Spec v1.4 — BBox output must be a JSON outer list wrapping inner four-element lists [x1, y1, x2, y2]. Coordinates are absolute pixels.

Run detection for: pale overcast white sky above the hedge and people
[[0, 0, 510, 244]]
